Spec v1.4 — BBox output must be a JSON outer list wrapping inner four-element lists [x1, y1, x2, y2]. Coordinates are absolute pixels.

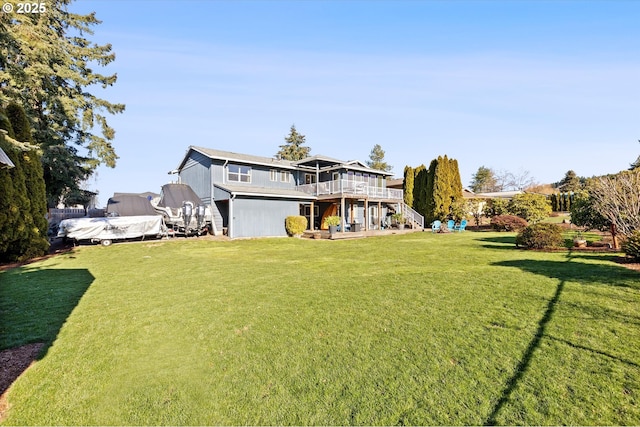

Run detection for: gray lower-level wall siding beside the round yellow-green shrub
[[230, 197, 300, 238]]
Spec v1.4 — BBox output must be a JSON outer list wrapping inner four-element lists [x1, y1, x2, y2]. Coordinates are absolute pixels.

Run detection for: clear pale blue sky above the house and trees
[[70, 0, 640, 205]]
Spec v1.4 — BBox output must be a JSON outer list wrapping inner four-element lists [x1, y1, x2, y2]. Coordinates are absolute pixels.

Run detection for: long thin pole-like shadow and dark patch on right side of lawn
[[485, 254, 640, 425]]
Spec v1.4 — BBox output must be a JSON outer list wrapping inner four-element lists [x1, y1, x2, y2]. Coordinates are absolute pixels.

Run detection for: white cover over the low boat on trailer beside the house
[[58, 215, 163, 240]]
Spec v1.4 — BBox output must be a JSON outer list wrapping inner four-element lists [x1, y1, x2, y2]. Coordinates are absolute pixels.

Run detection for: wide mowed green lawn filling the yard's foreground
[[0, 232, 640, 425]]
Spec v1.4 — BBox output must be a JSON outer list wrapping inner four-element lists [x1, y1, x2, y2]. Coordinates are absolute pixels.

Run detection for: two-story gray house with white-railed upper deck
[[176, 146, 420, 238]]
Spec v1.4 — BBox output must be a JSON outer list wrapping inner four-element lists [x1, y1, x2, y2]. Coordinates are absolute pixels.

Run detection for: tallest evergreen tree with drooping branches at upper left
[[0, 0, 125, 204]]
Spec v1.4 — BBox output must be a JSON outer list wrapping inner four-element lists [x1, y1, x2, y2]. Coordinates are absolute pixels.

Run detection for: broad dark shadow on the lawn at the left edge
[[0, 266, 94, 395]]
